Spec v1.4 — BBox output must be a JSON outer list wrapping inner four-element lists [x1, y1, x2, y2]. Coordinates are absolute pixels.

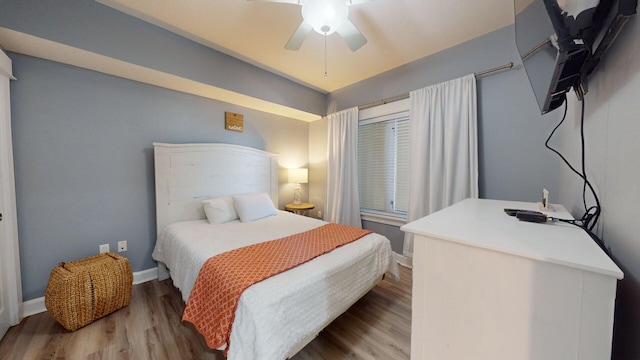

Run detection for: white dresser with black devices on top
[[401, 199, 623, 360]]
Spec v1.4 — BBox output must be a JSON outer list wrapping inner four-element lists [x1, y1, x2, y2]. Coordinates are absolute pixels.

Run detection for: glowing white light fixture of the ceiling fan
[[302, 0, 349, 36]]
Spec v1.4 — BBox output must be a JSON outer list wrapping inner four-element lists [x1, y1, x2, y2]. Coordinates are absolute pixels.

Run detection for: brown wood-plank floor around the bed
[[0, 267, 411, 360]]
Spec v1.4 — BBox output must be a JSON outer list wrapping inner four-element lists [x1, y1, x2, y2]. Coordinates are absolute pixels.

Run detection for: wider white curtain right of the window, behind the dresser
[[403, 74, 478, 257]]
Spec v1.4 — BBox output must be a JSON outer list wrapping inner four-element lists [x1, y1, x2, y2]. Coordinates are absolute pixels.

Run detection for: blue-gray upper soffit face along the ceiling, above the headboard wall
[[0, 0, 325, 114]]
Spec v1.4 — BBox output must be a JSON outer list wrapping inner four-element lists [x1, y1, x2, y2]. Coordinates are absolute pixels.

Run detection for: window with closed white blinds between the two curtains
[[358, 101, 409, 225]]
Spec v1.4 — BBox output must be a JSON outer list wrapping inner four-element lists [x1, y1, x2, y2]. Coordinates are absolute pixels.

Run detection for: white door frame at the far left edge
[[0, 49, 23, 334]]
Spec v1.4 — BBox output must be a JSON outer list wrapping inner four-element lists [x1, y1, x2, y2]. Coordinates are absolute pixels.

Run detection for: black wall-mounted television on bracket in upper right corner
[[514, 0, 638, 114]]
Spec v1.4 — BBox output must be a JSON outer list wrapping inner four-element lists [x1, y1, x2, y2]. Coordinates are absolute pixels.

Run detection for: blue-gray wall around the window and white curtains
[[310, 26, 561, 253]]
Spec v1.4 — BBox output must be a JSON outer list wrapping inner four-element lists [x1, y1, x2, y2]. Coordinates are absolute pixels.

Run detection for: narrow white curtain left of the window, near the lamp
[[325, 108, 362, 228]]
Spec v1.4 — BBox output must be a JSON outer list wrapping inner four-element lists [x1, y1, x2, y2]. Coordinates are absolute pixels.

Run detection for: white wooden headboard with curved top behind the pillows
[[153, 142, 278, 233]]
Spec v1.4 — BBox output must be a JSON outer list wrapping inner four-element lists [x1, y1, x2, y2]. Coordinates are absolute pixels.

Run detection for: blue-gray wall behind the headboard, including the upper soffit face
[[0, 0, 318, 300]]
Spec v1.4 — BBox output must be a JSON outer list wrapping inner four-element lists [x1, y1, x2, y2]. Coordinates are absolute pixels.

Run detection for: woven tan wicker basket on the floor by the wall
[[44, 253, 133, 331]]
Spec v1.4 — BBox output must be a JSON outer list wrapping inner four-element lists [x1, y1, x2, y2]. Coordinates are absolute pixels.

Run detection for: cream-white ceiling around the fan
[[97, 0, 514, 92]]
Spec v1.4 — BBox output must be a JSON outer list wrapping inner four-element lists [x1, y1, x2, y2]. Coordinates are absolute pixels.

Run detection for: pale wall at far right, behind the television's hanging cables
[[556, 17, 640, 360]]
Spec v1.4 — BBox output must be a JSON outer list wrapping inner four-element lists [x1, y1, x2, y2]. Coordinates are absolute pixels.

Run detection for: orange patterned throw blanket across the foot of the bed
[[182, 223, 371, 355]]
